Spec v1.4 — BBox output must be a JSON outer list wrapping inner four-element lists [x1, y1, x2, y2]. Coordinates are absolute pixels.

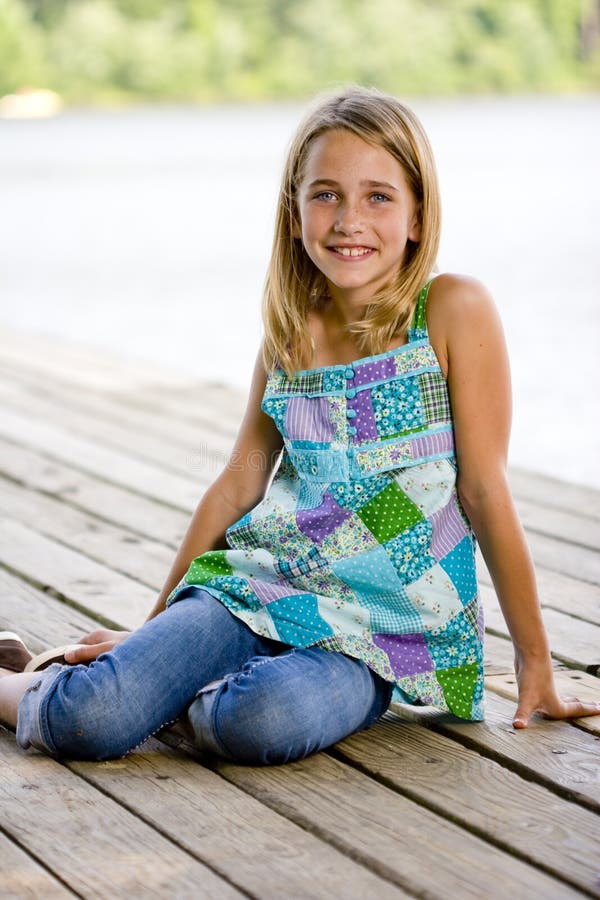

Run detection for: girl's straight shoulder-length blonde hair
[[262, 87, 441, 376]]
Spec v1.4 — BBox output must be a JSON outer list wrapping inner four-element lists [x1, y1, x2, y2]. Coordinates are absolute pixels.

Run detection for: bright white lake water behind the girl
[[0, 96, 600, 487]]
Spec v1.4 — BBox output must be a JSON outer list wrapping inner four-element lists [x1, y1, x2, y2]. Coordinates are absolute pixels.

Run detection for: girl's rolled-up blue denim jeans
[[17, 588, 392, 765]]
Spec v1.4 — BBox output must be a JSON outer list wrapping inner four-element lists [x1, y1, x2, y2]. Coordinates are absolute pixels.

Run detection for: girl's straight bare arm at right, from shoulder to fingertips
[[427, 275, 600, 728]]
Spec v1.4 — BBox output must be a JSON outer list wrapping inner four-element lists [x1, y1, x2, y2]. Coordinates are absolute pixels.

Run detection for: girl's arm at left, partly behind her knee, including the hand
[[65, 349, 283, 663]]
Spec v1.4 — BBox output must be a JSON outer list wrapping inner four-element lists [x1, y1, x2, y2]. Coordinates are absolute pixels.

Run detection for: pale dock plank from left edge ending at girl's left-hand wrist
[[0, 519, 156, 628]]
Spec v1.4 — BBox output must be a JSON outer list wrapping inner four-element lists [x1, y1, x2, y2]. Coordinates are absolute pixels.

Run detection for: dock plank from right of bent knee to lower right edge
[[336, 714, 600, 897]]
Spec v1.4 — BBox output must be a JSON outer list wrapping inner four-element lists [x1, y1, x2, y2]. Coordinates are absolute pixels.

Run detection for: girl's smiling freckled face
[[294, 129, 420, 307]]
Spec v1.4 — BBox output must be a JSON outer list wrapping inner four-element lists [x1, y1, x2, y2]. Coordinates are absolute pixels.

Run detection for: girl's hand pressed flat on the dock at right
[[513, 656, 600, 728]]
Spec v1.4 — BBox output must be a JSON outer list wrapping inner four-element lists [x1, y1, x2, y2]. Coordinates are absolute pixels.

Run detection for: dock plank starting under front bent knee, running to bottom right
[[215, 753, 579, 900]]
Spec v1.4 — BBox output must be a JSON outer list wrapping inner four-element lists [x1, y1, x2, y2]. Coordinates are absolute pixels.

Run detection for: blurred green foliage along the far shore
[[0, 0, 600, 102]]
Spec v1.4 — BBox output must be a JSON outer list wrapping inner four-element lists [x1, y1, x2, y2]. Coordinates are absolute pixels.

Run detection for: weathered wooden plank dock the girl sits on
[[0, 330, 600, 900]]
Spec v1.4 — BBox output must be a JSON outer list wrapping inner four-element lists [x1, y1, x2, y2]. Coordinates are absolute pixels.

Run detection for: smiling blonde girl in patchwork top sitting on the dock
[[0, 88, 600, 764]]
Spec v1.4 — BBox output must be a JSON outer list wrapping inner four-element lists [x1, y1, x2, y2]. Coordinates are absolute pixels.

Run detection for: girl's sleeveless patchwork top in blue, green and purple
[[167, 282, 483, 719]]
